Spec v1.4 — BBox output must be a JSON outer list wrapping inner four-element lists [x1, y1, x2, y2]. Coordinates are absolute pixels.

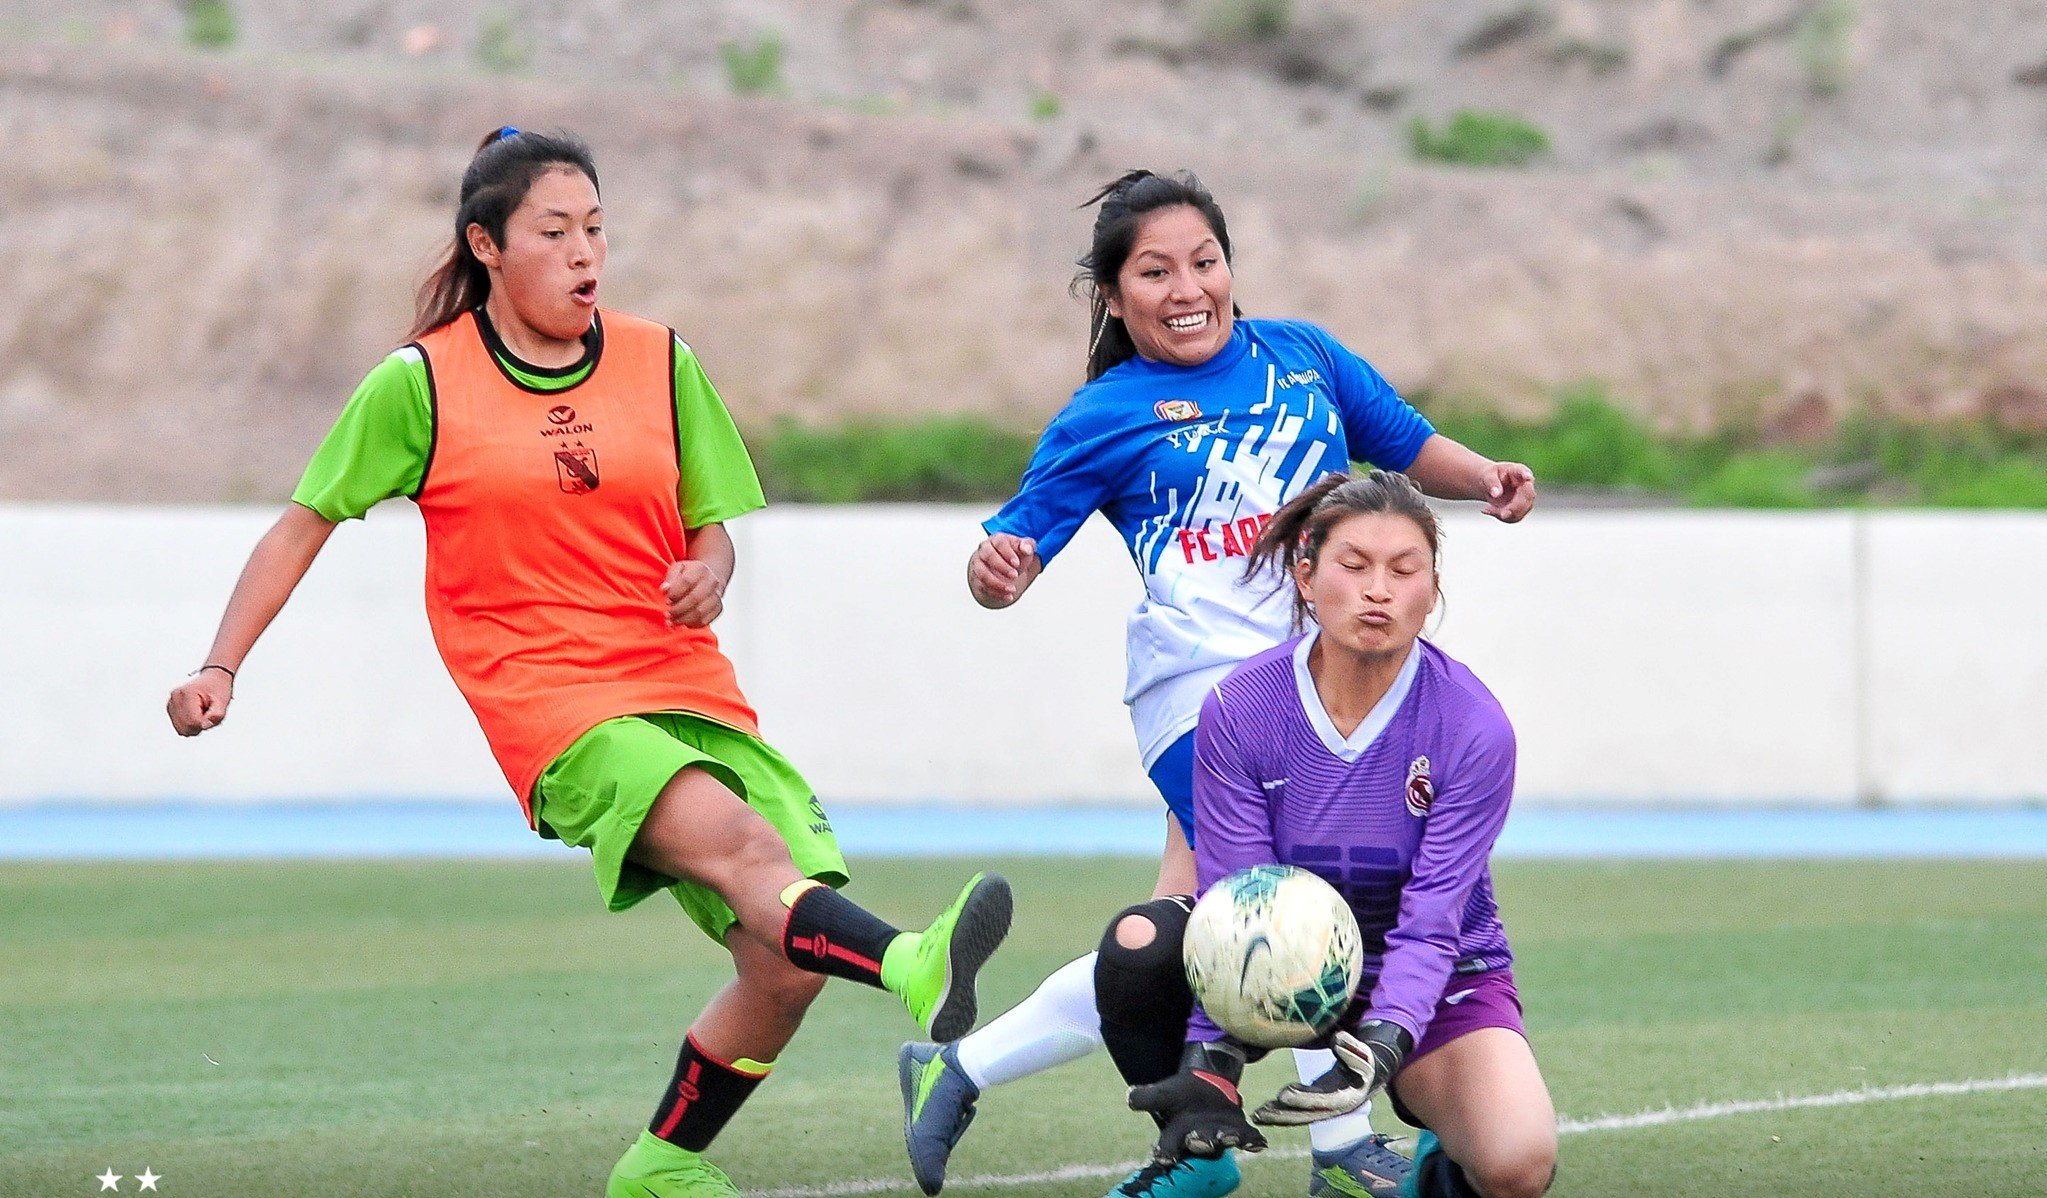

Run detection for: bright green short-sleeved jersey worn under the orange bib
[[291, 313, 766, 528]]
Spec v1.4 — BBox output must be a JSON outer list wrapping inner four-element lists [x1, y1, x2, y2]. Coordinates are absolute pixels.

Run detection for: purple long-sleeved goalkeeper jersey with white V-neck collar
[[1189, 631, 1515, 1042]]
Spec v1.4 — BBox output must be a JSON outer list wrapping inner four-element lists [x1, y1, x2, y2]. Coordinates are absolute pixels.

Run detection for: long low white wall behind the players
[[0, 504, 2047, 805]]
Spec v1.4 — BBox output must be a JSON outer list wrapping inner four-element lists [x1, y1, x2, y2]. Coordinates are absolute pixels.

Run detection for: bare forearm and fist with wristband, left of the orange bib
[[164, 504, 334, 737]]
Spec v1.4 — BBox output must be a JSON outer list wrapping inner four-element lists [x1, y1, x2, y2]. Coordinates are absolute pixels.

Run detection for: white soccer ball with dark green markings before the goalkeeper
[[1181, 864, 1365, 1049]]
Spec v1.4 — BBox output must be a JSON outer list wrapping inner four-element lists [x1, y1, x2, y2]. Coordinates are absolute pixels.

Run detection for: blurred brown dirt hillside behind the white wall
[[0, 0, 2047, 500]]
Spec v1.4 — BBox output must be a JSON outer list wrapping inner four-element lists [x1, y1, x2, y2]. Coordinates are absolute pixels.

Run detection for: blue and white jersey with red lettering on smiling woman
[[985, 319, 1435, 768]]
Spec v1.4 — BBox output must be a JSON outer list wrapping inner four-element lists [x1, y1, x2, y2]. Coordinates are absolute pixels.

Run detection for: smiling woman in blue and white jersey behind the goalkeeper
[[901, 170, 1535, 1198]]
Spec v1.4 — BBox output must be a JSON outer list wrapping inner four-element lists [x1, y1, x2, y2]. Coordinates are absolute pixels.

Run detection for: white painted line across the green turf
[[751, 1073, 2047, 1198]]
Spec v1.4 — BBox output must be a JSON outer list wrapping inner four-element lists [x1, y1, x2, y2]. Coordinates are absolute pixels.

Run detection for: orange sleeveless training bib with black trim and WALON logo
[[418, 311, 759, 823]]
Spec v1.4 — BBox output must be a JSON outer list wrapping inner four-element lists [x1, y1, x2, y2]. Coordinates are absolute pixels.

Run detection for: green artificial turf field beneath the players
[[0, 856, 2047, 1198]]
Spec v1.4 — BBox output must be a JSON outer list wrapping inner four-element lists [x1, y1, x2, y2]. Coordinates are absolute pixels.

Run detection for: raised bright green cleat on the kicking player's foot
[[882, 874, 1015, 1044]]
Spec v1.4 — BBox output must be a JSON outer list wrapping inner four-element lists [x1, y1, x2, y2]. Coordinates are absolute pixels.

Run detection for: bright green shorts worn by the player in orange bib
[[532, 711, 847, 944]]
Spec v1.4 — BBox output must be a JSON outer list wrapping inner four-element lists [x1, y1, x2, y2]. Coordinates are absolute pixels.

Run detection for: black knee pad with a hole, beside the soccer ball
[[1095, 895, 1193, 1085]]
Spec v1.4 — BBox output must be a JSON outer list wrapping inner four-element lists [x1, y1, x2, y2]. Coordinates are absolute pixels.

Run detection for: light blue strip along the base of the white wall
[[0, 799, 2047, 860]]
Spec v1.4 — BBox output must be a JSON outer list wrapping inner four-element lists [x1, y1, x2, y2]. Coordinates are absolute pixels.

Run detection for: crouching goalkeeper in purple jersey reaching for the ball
[[1130, 471, 1556, 1198]]
